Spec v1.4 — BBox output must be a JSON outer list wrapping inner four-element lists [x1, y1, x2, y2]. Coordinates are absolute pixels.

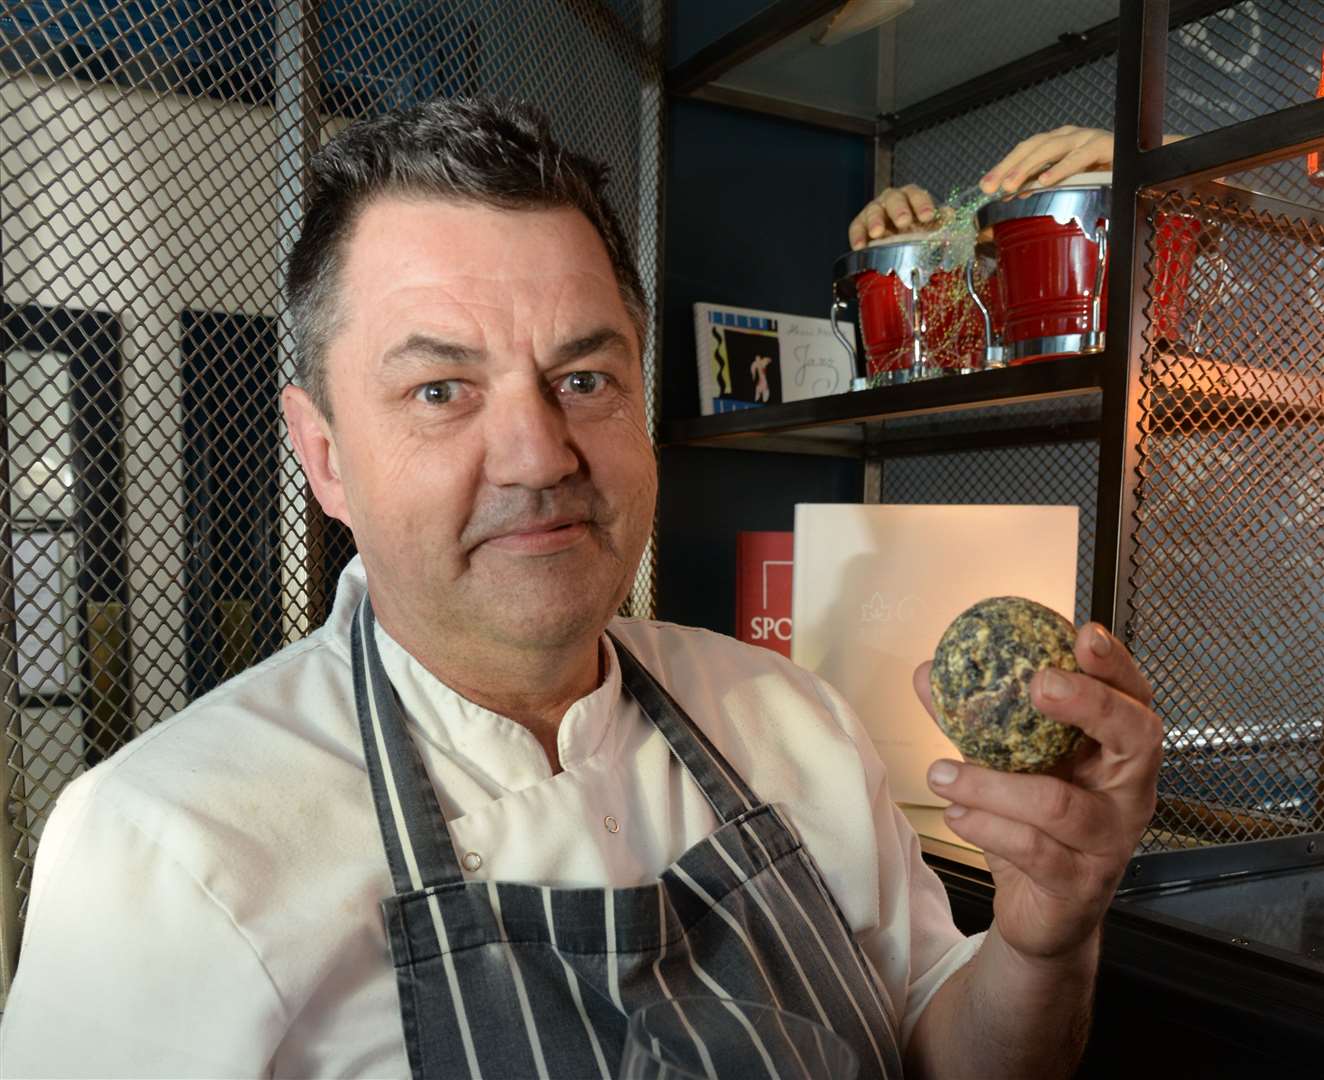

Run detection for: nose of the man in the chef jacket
[[485, 385, 580, 490]]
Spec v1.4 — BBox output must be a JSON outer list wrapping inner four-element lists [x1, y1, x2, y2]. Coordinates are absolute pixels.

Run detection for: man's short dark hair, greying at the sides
[[286, 98, 649, 420]]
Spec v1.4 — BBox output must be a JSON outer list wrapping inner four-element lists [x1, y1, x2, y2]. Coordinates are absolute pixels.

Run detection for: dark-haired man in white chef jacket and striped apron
[[0, 101, 1159, 1079]]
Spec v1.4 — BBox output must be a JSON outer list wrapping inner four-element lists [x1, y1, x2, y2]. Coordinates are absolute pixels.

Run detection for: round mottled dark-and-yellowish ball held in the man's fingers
[[929, 597, 1080, 773]]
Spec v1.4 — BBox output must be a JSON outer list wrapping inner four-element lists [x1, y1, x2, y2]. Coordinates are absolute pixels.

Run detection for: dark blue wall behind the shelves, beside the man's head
[[658, 99, 873, 634]]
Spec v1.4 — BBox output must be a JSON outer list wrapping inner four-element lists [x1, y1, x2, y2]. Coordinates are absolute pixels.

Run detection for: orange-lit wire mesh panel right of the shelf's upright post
[[1129, 191, 1324, 850]]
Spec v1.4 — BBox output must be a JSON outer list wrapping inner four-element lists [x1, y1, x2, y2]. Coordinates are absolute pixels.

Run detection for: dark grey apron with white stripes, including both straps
[[352, 597, 900, 1080]]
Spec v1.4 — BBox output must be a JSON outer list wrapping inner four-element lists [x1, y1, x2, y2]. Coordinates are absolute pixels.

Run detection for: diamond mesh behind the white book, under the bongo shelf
[[882, 442, 1099, 623]]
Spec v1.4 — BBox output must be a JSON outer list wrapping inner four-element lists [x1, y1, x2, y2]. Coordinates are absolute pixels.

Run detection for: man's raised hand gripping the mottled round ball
[[915, 623, 1162, 961]]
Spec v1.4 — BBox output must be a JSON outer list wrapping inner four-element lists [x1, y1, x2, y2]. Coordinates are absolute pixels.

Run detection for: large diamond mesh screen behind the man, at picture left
[[0, 0, 662, 958]]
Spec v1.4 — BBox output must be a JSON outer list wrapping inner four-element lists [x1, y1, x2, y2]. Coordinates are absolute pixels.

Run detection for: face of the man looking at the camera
[[318, 197, 657, 650]]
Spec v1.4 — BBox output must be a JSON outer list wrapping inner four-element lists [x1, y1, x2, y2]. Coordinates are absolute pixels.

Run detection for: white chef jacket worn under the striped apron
[[0, 560, 980, 1077]]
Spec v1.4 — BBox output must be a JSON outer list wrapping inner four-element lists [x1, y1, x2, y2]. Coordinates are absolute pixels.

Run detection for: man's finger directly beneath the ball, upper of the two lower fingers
[[928, 760, 1115, 854]]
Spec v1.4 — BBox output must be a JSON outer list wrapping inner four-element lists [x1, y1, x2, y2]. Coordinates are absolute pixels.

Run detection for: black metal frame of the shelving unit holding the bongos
[[659, 0, 1324, 910]]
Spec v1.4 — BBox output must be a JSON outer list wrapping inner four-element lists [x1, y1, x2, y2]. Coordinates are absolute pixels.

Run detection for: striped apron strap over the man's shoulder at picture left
[[350, 593, 465, 893]]
